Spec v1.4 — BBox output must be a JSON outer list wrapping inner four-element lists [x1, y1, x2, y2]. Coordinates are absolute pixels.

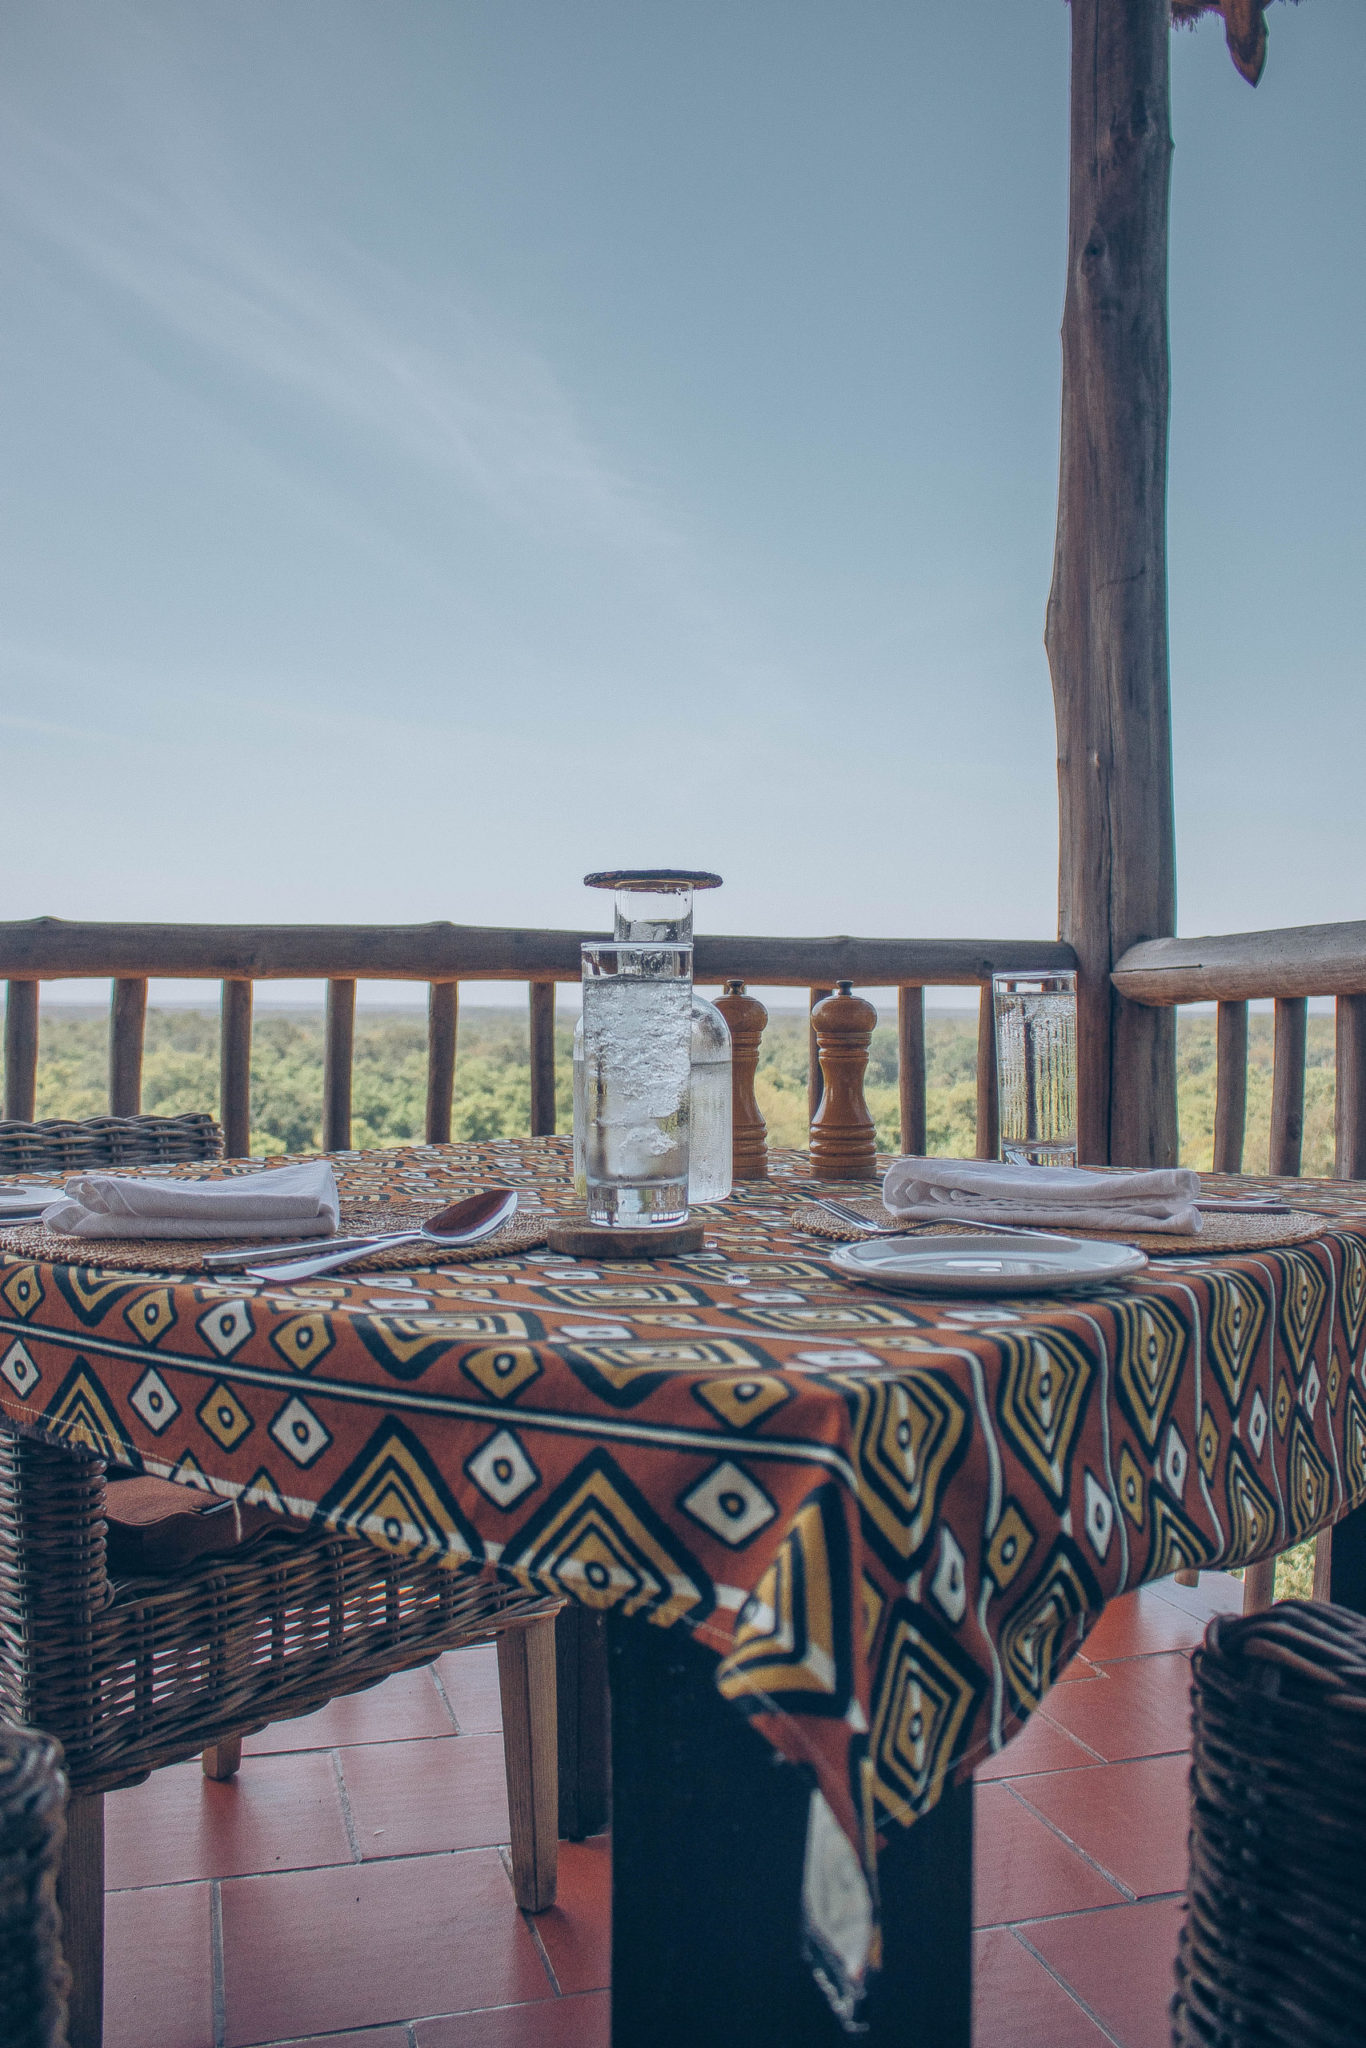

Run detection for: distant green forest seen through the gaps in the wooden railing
[[0, 1006, 1333, 1174]]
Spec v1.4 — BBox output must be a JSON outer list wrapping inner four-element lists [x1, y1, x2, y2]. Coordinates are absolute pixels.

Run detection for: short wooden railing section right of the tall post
[[1110, 924, 1366, 1180]]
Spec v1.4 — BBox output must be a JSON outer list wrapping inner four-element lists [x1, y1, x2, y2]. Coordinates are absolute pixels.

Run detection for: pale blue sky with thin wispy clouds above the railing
[[0, 0, 1366, 966]]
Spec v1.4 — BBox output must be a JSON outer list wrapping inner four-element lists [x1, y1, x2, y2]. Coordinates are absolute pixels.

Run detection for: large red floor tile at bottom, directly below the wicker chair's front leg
[[223, 1849, 551, 2048]]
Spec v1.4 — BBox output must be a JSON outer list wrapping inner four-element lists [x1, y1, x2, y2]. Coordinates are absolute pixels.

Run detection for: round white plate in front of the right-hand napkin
[[829, 1231, 1147, 1294]]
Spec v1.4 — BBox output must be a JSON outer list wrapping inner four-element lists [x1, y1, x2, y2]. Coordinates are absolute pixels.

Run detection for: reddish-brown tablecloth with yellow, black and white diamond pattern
[[0, 1139, 1366, 2001]]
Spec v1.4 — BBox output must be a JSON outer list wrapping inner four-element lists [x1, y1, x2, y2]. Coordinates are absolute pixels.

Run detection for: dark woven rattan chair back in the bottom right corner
[[1171, 1602, 1366, 2048]]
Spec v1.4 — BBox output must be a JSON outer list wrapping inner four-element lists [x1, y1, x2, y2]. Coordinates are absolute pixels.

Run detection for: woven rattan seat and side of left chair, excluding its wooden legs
[[0, 1432, 557, 1802]]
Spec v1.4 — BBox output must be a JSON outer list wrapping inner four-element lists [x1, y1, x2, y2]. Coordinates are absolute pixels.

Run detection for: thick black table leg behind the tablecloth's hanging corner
[[608, 1616, 973, 2048]]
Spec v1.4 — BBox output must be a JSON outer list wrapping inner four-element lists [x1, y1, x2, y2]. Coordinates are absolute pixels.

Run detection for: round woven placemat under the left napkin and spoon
[[0, 1202, 551, 1280]]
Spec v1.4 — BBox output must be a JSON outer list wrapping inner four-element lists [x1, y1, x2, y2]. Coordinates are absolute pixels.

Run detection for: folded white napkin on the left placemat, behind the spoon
[[43, 1159, 338, 1241]]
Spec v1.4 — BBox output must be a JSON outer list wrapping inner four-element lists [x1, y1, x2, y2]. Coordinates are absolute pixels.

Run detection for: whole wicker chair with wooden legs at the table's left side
[[0, 1118, 559, 2048]]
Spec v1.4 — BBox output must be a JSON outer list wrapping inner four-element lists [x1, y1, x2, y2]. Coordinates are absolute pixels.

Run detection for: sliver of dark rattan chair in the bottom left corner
[[0, 1726, 70, 2048]]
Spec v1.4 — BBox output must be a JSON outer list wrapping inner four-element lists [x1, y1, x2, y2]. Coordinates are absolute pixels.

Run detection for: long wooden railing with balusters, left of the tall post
[[0, 918, 1075, 1157]]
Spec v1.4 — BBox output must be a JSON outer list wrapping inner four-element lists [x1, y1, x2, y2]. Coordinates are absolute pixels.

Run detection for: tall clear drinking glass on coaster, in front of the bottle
[[582, 940, 692, 1227]]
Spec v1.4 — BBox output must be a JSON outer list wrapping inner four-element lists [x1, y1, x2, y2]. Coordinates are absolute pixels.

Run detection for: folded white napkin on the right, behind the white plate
[[883, 1159, 1200, 1233]]
